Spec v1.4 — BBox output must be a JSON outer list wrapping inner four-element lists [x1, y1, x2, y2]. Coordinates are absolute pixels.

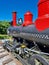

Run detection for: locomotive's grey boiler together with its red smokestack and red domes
[[7, 0, 49, 51]]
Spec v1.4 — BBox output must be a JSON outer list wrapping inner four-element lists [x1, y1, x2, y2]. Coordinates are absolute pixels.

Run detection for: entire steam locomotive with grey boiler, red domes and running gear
[[4, 0, 49, 65]]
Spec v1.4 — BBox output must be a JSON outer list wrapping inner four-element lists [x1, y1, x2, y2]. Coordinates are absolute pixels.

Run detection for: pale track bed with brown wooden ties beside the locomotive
[[0, 45, 22, 65]]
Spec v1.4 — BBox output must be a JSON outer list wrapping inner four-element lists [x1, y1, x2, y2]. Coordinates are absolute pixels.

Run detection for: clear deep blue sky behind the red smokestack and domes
[[0, 0, 38, 21]]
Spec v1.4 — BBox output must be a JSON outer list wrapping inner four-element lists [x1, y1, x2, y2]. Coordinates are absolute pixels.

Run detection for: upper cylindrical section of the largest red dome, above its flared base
[[38, 0, 49, 17]]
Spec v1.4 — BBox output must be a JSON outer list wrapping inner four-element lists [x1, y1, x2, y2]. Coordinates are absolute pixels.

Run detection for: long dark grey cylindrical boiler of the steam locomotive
[[7, 25, 49, 51]]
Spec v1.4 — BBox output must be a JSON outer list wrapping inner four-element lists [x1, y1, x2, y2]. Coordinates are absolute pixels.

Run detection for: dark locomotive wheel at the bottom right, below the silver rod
[[29, 54, 49, 65]]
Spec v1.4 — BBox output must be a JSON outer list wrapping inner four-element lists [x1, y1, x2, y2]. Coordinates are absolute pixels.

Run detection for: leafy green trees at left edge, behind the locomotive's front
[[0, 21, 10, 34]]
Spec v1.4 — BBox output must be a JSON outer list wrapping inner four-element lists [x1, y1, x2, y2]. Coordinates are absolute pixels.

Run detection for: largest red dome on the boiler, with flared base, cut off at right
[[35, 0, 49, 31]]
